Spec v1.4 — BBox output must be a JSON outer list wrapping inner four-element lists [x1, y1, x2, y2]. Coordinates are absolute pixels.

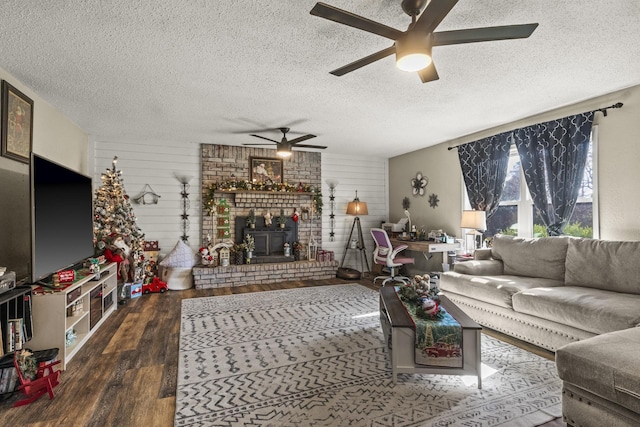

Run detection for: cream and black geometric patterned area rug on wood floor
[[175, 284, 561, 427]]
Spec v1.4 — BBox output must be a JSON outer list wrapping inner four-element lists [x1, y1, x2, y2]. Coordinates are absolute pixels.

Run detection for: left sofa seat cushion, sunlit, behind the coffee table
[[440, 272, 563, 308]]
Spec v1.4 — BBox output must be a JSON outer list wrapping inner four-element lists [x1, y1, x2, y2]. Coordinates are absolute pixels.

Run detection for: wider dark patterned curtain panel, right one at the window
[[513, 111, 594, 236]]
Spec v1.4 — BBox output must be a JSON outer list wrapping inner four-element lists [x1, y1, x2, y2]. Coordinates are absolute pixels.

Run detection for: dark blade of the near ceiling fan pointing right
[[433, 23, 538, 46]]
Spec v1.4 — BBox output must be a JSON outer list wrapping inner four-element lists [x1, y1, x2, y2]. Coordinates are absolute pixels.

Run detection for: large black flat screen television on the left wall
[[31, 154, 94, 283]]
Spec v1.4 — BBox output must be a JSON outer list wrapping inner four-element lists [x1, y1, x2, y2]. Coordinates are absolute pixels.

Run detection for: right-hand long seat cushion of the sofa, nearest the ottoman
[[512, 286, 640, 334]]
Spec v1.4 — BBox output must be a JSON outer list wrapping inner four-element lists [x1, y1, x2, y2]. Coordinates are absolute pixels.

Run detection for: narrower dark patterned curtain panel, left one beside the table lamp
[[458, 132, 512, 218]]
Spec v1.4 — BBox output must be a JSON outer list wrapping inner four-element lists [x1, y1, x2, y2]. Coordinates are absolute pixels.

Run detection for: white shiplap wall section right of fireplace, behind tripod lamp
[[322, 152, 389, 271]]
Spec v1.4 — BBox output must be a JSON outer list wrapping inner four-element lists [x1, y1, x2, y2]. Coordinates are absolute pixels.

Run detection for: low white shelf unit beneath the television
[[29, 263, 118, 370]]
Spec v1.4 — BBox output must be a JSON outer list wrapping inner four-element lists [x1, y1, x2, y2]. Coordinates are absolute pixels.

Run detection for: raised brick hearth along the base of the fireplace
[[193, 261, 338, 289]]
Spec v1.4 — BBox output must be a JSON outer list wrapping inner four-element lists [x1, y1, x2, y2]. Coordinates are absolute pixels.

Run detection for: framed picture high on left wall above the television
[[0, 80, 33, 163]]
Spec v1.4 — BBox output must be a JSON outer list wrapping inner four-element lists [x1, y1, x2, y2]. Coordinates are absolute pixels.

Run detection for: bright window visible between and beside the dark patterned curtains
[[484, 126, 598, 241]]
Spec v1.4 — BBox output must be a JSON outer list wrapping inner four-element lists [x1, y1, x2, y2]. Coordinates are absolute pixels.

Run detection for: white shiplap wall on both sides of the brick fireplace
[[92, 141, 388, 269]]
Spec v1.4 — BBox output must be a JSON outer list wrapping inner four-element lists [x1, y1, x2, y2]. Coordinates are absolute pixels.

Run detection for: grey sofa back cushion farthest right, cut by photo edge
[[565, 239, 640, 295]]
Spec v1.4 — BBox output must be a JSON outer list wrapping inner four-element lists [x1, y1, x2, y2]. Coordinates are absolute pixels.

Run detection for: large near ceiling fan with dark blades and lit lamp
[[311, 0, 538, 83]]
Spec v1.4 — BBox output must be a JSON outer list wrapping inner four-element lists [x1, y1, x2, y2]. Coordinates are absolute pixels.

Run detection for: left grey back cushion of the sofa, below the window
[[491, 235, 570, 281]]
